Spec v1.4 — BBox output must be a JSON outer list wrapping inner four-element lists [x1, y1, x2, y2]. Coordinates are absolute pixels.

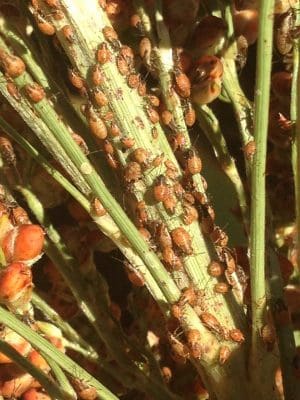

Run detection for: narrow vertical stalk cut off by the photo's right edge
[[290, 2, 300, 277]]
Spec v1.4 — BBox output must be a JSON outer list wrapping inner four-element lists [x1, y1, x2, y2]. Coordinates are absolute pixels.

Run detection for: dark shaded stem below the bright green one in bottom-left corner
[[0, 339, 76, 400]]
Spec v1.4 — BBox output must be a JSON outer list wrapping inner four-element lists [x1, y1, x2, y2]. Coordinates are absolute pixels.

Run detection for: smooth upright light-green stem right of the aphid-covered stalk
[[250, 0, 274, 388]]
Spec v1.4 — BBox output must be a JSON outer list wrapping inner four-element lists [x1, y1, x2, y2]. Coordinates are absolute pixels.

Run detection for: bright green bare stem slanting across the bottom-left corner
[[0, 307, 118, 400]]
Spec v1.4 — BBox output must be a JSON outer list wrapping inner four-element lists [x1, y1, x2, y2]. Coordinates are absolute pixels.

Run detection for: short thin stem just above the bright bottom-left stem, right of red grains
[[31, 291, 99, 360]]
